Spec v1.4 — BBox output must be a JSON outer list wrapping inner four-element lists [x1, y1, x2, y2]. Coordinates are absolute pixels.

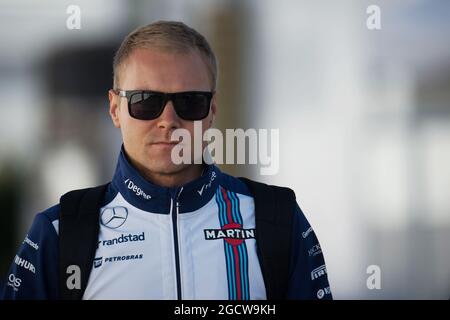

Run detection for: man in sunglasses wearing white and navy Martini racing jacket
[[3, 21, 331, 300]]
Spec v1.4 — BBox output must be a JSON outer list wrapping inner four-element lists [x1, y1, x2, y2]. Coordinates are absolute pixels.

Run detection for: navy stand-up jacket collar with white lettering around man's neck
[[112, 146, 222, 214]]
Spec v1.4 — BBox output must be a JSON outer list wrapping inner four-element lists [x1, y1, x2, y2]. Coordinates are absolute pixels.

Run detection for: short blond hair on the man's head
[[113, 21, 217, 91]]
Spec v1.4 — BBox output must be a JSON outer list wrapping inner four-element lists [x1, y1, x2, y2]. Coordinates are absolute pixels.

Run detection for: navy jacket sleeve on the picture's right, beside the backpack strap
[[287, 205, 333, 300]]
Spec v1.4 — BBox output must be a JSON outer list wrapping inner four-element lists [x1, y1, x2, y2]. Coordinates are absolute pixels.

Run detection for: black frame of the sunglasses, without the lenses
[[112, 89, 215, 121]]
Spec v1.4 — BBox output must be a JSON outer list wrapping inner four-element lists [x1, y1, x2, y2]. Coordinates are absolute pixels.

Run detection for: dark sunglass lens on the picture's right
[[175, 93, 210, 120]]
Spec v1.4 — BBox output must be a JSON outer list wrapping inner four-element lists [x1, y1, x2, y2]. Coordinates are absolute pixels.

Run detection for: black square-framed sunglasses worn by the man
[[113, 89, 213, 121]]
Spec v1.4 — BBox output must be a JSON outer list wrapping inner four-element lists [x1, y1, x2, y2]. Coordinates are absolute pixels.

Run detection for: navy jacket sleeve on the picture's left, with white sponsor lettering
[[0, 209, 59, 300]]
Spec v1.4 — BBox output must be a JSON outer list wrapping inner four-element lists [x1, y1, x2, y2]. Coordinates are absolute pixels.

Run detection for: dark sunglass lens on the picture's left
[[130, 92, 164, 120]]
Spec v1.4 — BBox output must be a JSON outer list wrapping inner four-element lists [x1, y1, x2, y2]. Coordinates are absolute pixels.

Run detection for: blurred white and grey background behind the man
[[0, 0, 450, 299]]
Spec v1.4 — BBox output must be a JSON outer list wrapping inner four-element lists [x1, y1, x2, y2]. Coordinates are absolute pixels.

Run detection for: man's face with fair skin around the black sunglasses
[[109, 49, 216, 175]]
